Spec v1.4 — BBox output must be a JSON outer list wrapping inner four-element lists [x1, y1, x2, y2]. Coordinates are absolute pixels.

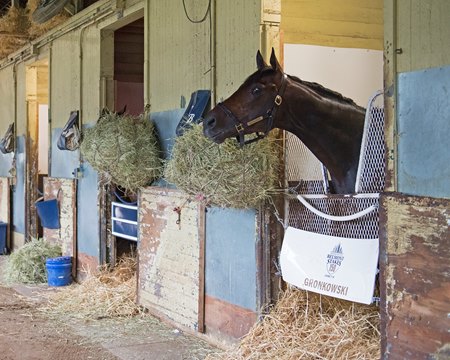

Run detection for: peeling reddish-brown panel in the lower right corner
[[380, 194, 450, 360]]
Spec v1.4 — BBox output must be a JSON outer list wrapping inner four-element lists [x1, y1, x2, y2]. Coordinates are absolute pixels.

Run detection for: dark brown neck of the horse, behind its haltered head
[[275, 85, 364, 193]]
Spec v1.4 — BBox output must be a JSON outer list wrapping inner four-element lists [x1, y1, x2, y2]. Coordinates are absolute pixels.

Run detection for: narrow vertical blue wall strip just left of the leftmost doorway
[[13, 136, 25, 234]]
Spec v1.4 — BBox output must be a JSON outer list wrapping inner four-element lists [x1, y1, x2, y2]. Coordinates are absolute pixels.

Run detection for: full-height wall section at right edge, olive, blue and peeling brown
[[380, 0, 450, 359]]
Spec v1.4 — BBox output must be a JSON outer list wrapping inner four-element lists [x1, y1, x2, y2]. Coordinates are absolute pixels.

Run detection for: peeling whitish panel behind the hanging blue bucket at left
[[44, 177, 76, 257]]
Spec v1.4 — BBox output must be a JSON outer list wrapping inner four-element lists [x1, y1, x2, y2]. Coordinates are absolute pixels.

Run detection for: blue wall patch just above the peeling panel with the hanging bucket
[[50, 129, 80, 179]]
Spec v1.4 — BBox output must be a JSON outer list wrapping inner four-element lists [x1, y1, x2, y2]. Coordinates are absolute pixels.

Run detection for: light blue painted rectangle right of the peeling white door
[[205, 208, 257, 311]]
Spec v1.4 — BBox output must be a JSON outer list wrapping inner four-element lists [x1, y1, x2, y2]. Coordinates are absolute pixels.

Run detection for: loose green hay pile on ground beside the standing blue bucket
[[4, 239, 61, 284]]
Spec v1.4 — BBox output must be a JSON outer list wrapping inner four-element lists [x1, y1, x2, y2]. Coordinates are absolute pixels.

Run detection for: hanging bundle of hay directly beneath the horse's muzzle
[[164, 125, 279, 208]]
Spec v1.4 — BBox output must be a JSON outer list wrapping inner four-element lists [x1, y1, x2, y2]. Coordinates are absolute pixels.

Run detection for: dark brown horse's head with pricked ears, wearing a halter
[[203, 49, 286, 146]]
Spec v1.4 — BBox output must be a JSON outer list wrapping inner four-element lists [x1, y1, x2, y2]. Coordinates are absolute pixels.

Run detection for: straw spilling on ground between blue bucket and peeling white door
[[40, 257, 141, 319]]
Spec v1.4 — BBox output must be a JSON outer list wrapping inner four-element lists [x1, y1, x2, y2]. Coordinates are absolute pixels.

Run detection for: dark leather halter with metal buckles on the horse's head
[[217, 73, 287, 147]]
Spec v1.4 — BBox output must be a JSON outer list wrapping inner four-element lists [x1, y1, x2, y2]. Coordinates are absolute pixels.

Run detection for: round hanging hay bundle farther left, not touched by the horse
[[80, 111, 162, 192]]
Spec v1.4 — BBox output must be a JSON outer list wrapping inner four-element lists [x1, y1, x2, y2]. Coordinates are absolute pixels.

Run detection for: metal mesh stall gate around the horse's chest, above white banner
[[286, 94, 385, 239]]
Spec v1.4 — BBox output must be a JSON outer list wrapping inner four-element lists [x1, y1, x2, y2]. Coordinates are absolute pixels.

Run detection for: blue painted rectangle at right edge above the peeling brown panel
[[397, 66, 450, 198]]
